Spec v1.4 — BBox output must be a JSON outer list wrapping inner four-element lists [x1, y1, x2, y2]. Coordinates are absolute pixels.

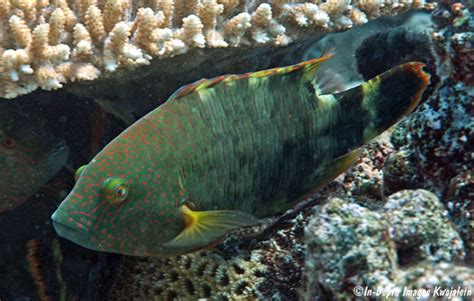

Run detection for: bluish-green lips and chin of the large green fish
[[51, 212, 103, 251]]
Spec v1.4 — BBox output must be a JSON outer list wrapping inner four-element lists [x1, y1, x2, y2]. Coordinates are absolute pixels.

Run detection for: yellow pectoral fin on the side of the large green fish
[[165, 205, 258, 252]]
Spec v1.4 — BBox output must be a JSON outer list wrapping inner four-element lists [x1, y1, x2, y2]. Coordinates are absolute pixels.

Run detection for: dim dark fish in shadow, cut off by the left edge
[[0, 103, 69, 213]]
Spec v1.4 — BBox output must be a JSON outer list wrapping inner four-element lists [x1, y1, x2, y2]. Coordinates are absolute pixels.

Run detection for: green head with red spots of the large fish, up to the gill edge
[[52, 121, 184, 256]]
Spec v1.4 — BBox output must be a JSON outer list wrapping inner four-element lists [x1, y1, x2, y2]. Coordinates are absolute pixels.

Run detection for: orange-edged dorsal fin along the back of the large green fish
[[168, 54, 333, 100]]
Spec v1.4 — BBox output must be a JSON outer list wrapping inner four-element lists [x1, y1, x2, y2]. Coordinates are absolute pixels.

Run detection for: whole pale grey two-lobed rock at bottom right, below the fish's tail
[[303, 190, 464, 300]]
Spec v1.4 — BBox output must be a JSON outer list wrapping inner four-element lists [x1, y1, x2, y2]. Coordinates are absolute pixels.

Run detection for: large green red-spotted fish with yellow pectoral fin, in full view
[[52, 55, 429, 256]]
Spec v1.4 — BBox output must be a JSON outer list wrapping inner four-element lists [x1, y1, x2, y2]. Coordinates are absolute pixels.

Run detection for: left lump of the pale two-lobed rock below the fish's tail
[[305, 198, 397, 300]]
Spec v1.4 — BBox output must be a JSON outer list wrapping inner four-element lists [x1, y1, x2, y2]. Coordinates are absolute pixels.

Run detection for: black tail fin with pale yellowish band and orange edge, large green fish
[[335, 62, 430, 143]]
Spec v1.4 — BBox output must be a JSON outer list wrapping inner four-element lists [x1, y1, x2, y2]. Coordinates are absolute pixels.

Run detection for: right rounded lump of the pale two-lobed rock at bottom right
[[382, 189, 464, 265]]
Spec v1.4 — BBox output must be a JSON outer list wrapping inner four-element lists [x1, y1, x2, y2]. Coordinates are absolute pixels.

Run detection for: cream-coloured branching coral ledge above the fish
[[0, 0, 431, 98]]
